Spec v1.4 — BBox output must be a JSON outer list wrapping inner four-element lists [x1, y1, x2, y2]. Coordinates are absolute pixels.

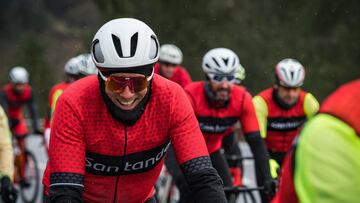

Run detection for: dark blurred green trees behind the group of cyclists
[[0, 0, 360, 116]]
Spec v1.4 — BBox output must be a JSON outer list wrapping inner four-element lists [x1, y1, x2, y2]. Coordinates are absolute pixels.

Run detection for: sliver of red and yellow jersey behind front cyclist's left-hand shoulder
[[44, 82, 71, 128]]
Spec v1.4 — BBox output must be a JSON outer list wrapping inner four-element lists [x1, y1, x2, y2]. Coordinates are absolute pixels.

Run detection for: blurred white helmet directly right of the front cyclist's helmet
[[159, 44, 183, 64]]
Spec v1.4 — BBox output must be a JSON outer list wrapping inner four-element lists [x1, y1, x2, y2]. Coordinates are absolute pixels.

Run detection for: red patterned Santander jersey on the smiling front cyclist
[[43, 75, 208, 202]]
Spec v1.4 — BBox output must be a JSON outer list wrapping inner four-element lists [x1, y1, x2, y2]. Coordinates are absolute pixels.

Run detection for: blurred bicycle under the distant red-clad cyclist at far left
[[14, 135, 40, 203]]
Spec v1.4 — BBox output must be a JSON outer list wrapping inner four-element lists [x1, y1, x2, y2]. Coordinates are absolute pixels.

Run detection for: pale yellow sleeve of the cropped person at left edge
[[0, 106, 14, 179]]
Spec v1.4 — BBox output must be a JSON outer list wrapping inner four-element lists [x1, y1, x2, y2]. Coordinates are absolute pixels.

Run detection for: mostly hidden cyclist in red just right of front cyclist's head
[[154, 44, 191, 87]]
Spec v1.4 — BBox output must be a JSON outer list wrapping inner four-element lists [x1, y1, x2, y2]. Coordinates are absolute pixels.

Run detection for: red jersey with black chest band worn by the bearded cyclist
[[185, 82, 259, 153]]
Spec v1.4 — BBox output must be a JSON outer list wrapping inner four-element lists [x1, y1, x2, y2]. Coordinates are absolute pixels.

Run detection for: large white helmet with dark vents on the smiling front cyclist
[[91, 18, 159, 70]]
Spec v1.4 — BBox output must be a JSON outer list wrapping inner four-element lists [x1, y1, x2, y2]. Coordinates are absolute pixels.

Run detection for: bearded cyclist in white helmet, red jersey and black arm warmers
[[181, 48, 275, 201]]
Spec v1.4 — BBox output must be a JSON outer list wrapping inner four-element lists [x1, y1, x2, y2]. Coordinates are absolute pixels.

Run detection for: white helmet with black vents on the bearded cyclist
[[202, 48, 240, 75]]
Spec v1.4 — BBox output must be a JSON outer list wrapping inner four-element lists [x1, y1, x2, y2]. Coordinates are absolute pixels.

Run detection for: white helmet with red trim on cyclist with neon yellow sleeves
[[275, 58, 305, 87]]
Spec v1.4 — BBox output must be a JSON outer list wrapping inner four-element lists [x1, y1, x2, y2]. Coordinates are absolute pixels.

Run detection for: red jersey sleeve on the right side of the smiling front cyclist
[[170, 85, 208, 165]]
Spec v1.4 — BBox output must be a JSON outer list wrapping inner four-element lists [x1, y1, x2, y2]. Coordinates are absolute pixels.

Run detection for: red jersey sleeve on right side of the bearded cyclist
[[240, 92, 259, 134]]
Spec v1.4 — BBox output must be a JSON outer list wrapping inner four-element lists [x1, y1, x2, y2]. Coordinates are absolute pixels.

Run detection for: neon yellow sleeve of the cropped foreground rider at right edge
[[295, 114, 360, 203]]
